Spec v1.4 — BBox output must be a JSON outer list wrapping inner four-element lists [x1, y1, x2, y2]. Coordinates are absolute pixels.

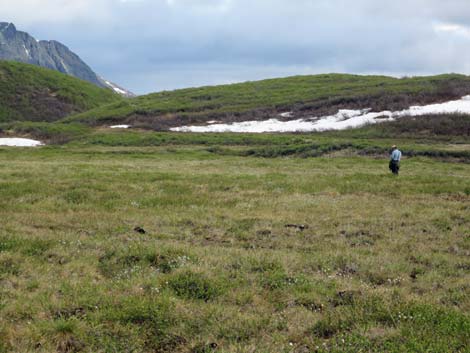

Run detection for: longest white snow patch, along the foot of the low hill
[[171, 96, 470, 133]]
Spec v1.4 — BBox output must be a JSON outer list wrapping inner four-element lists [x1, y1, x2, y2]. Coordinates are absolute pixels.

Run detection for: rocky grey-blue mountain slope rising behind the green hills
[[0, 22, 133, 96]]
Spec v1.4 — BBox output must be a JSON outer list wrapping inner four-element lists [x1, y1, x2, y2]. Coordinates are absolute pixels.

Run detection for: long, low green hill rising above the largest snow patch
[[66, 74, 470, 129]]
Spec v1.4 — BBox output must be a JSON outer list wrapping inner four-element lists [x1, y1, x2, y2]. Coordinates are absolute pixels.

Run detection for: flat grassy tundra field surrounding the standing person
[[0, 130, 470, 353]]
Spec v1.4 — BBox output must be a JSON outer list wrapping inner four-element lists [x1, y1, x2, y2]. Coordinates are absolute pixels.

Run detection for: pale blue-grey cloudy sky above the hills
[[0, 0, 470, 94]]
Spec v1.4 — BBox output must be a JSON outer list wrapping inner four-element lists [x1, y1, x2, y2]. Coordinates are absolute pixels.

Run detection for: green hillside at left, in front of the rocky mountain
[[0, 61, 122, 122]]
